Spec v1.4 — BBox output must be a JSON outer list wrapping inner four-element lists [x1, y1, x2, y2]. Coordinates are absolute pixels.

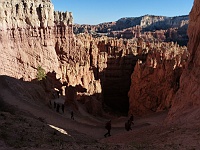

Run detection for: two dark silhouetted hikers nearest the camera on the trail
[[104, 114, 134, 137]]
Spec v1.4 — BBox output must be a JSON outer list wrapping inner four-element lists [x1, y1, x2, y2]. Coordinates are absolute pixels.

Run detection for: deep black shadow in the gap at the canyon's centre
[[93, 54, 146, 116]]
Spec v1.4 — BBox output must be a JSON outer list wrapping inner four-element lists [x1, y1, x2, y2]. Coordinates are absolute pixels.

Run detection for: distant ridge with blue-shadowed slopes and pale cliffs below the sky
[[74, 15, 189, 46]]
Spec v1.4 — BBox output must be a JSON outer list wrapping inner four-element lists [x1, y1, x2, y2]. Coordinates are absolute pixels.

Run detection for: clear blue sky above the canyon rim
[[51, 0, 194, 24]]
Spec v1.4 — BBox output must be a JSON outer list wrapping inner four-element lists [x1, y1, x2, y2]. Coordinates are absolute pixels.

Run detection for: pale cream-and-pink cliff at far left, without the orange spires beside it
[[0, 0, 72, 80]]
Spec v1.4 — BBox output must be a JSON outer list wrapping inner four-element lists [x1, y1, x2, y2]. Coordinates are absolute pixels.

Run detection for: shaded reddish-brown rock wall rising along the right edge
[[168, 0, 200, 123]]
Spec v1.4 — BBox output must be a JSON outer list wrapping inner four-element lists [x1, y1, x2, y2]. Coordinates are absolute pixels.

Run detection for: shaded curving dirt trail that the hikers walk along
[[0, 77, 172, 149]]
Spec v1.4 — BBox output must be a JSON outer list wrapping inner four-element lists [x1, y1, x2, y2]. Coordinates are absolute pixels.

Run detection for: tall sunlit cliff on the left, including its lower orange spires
[[0, 0, 101, 114]]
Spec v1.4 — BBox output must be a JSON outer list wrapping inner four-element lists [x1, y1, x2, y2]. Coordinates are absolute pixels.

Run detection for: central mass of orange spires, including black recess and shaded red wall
[[77, 34, 189, 115]]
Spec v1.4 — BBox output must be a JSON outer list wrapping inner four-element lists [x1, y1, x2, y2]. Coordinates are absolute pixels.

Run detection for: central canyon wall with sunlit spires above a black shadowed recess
[[76, 34, 141, 113]]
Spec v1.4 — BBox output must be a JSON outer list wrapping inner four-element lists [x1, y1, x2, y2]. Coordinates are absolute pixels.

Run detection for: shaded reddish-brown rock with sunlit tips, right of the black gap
[[128, 43, 189, 116]]
